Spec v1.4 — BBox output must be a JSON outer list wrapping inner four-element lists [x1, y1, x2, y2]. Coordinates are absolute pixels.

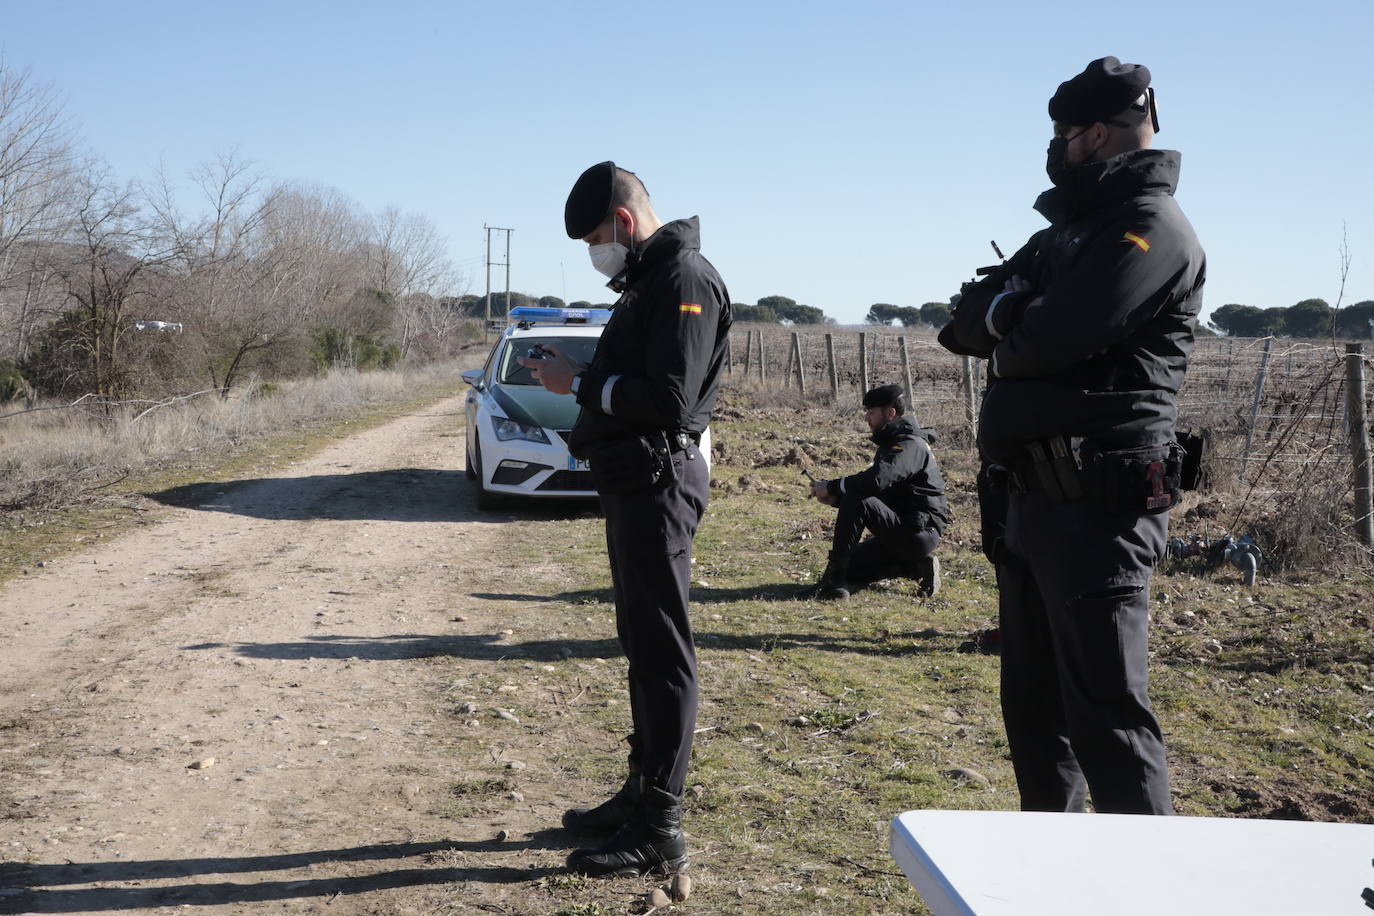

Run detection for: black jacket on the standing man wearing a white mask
[[567, 217, 731, 457]]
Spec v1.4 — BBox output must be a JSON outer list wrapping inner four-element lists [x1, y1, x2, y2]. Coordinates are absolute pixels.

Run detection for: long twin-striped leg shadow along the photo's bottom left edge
[[0, 829, 573, 913]]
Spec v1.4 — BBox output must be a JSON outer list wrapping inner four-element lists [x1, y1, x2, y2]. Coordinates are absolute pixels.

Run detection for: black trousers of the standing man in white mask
[[600, 445, 710, 797]]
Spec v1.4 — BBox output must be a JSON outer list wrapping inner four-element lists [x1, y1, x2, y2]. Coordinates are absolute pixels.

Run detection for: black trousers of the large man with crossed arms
[[998, 493, 1173, 814]]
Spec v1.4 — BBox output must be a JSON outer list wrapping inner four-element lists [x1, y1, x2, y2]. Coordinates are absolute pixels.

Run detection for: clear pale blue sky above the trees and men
[[0, 0, 1374, 323]]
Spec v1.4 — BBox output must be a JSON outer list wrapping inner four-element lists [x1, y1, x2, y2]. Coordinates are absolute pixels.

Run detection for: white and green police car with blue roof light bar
[[463, 306, 610, 509]]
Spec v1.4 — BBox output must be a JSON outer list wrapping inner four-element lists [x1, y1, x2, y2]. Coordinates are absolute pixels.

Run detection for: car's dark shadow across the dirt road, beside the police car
[[144, 467, 594, 522]]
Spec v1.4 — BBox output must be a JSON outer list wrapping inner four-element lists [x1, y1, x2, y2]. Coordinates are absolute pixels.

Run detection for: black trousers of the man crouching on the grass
[[830, 494, 940, 584]]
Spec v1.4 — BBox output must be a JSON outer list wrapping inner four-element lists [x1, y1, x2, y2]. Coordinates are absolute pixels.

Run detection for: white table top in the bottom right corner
[[890, 810, 1374, 916]]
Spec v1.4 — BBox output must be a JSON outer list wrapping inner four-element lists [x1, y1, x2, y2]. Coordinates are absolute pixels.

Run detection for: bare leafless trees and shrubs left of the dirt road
[[0, 59, 463, 400]]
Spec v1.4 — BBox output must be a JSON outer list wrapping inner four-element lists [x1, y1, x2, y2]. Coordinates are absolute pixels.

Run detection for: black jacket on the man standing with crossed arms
[[940, 150, 1206, 463]]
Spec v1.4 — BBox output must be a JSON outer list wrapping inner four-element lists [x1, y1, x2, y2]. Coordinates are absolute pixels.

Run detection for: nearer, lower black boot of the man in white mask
[[567, 787, 687, 878]]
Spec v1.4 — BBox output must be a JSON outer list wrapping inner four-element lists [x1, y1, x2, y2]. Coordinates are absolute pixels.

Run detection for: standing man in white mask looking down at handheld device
[[521, 162, 731, 876]]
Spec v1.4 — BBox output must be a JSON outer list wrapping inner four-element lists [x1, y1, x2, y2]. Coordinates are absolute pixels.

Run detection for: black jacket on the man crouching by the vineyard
[[829, 416, 949, 533]]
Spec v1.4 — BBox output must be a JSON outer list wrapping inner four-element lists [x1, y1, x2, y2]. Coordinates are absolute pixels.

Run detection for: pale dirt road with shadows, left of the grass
[[0, 398, 585, 913]]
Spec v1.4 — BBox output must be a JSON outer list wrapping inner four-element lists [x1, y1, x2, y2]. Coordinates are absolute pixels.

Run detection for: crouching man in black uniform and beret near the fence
[[811, 385, 949, 599]]
